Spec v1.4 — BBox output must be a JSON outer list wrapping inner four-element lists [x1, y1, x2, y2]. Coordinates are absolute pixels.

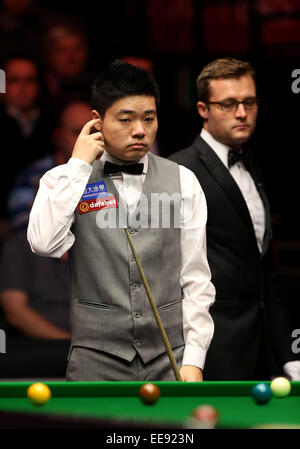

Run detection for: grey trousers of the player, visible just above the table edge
[[66, 346, 184, 381]]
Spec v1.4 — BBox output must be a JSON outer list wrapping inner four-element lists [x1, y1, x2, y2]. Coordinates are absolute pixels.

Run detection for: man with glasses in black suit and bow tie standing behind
[[170, 58, 300, 380]]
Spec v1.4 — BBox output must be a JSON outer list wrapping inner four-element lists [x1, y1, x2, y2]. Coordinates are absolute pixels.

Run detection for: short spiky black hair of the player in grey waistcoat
[[91, 59, 160, 117]]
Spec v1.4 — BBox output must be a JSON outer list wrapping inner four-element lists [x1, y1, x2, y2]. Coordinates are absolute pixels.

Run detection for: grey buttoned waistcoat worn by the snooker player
[[70, 154, 184, 363]]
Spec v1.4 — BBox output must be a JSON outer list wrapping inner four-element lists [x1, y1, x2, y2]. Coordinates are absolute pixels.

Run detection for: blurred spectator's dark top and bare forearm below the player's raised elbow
[[0, 230, 70, 339]]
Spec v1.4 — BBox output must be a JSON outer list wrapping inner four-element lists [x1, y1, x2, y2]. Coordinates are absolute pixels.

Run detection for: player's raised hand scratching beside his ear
[[72, 119, 104, 165]]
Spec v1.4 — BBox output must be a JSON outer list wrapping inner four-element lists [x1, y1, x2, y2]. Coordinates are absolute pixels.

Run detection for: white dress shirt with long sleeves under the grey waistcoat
[[27, 152, 215, 369]]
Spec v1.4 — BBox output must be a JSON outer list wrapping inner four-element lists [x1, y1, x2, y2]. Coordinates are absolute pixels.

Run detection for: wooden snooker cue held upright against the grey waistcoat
[[125, 228, 182, 382]]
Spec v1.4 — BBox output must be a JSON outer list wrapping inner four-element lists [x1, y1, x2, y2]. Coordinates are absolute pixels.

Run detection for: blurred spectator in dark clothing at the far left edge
[[0, 56, 52, 234]]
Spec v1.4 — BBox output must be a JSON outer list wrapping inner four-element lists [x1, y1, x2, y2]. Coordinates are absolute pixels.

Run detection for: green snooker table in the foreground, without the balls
[[0, 381, 300, 429]]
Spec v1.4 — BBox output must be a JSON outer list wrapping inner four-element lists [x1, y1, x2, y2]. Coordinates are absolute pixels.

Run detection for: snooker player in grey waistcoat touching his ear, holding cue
[[28, 61, 215, 381]]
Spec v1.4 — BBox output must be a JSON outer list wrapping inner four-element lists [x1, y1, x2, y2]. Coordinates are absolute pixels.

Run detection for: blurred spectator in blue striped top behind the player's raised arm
[[8, 102, 91, 231]]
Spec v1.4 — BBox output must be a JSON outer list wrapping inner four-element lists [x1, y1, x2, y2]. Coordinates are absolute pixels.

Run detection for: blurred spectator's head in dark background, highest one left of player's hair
[[45, 24, 92, 105]]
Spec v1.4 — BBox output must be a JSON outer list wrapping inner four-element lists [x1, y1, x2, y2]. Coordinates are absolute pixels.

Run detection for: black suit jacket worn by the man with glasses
[[170, 136, 293, 380]]
